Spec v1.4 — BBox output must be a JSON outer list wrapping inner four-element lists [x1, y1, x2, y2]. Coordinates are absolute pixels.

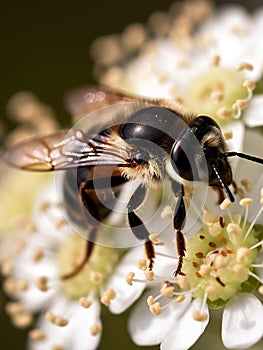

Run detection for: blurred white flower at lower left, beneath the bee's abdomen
[[1, 179, 139, 350]]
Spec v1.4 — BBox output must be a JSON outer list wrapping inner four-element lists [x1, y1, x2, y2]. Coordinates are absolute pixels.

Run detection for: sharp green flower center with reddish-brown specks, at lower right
[[183, 215, 258, 307]]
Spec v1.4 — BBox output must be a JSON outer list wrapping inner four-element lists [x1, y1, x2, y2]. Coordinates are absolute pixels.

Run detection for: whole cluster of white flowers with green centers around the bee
[[0, 0, 263, 350]]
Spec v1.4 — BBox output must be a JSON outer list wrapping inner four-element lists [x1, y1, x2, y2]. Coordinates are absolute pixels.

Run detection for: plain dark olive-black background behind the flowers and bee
[[0, 0, 262, 350]]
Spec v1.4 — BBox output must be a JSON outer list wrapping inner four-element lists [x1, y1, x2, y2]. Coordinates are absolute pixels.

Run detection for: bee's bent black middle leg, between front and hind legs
[[127, 185, 155, 270]]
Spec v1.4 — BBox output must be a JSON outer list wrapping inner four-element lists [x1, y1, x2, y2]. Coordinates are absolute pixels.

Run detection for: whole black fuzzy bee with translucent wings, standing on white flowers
[[4, 87, 263, 279]]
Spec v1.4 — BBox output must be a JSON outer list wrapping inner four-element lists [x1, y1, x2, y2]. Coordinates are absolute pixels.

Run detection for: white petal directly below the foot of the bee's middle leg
[[106, 247, 146, 314]]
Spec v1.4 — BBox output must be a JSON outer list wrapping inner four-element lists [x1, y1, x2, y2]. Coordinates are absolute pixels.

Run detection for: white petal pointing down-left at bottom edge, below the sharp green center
[[161, 299, 209, 350]]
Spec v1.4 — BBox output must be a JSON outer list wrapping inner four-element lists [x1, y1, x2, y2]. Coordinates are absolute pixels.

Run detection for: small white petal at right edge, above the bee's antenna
[[244, 95, 263, 127]]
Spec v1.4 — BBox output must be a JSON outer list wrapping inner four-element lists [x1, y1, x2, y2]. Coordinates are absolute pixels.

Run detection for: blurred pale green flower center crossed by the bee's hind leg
[[57, 235, 123, 299]]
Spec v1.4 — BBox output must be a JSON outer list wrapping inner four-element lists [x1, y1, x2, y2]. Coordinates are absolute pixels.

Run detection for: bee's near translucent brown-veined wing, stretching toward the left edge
[[4, 129, 131, 171]]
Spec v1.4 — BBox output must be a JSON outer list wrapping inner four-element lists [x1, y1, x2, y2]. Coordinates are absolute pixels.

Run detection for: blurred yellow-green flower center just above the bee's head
[[182, 67, 248, 123]]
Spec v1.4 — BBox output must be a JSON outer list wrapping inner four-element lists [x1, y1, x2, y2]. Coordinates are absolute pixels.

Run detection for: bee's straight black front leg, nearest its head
[[172, 181, 186, 276]]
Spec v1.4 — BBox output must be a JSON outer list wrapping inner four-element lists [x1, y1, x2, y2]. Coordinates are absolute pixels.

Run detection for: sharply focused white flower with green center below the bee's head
[[125, 132, 263, 350]]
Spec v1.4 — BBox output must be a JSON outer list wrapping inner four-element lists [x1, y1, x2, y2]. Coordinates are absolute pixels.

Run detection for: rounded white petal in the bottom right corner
[[222, 293, 263, 349]]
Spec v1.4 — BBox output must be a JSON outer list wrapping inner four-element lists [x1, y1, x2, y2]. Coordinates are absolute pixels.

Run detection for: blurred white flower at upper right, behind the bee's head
[[92, 0, 263, 126]]
